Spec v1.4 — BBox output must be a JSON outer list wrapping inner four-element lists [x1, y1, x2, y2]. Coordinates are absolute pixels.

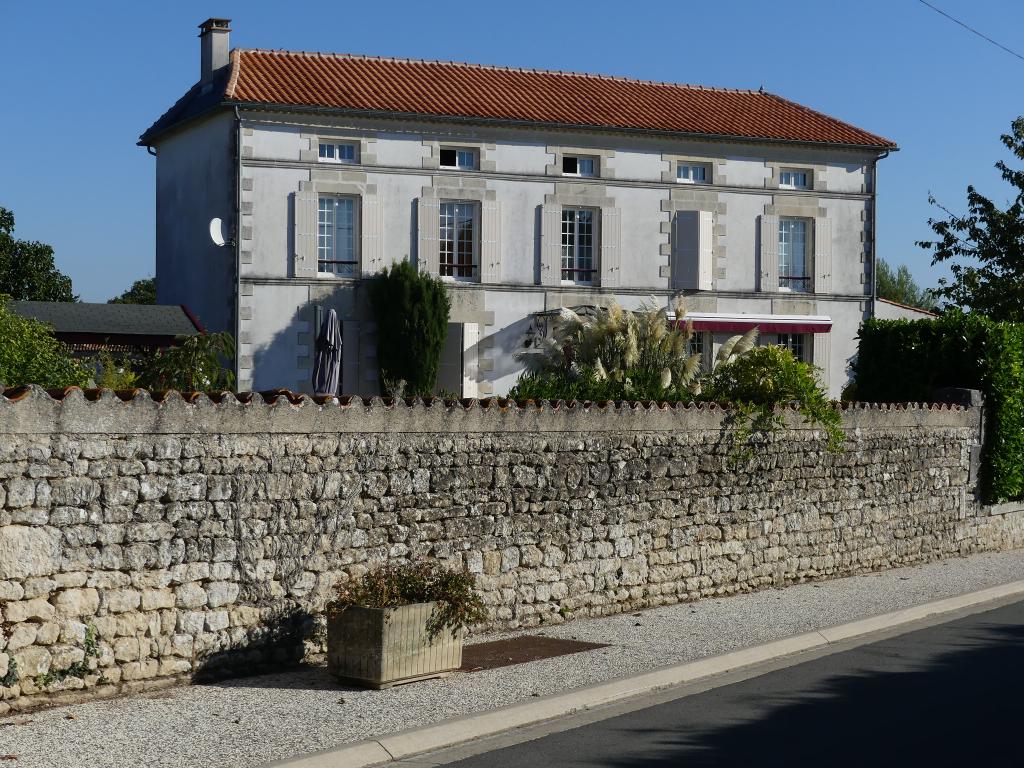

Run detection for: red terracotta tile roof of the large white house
[[143, 49, 896, 148]]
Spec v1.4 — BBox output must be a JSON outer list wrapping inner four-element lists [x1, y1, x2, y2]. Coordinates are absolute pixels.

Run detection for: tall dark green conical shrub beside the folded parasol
[[370, 261, 452, 396]]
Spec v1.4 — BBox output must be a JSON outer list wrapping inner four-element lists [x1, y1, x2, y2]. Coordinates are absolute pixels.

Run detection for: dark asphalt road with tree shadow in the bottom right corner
[[449, 602, 1024, 768]]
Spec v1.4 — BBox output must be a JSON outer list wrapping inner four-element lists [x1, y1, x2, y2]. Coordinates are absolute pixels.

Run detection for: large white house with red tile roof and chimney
[[140, 19, 896, 396]]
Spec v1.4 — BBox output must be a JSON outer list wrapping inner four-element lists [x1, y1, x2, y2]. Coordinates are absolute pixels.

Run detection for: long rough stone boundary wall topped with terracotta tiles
[[0, 387, 1024, 715]]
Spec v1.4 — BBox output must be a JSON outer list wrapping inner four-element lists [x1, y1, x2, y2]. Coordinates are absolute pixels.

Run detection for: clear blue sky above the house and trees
[[0, 0, 1024, 301]]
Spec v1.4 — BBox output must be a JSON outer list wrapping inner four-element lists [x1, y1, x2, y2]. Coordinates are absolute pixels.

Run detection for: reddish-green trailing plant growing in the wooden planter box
[[327, 560, 487, 638]]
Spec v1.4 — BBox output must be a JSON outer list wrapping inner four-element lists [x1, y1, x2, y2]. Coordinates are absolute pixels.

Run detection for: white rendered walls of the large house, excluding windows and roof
[[154, 110, 879, 396]]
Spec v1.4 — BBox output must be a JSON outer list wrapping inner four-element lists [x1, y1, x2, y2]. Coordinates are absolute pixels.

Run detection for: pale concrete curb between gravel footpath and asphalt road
[[270, 580, 1024, 768]]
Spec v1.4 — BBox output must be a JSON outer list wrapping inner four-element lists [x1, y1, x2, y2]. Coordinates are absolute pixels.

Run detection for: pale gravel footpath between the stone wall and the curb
[[6, 550, 1024, 768]]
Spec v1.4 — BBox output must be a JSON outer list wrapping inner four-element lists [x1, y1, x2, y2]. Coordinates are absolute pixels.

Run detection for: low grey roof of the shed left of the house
[[9, 301, 202, 336]]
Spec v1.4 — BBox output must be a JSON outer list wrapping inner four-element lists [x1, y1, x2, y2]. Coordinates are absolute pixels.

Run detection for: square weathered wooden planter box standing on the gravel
[[327, 603, 463, 689]]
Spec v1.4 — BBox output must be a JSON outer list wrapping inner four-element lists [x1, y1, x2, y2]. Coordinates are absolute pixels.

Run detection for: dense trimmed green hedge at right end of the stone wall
[[853, 312, 1024, 503]]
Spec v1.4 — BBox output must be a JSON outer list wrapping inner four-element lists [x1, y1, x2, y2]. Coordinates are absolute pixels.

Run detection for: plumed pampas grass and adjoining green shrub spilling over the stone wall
[[509, 303, 843, 458]]
